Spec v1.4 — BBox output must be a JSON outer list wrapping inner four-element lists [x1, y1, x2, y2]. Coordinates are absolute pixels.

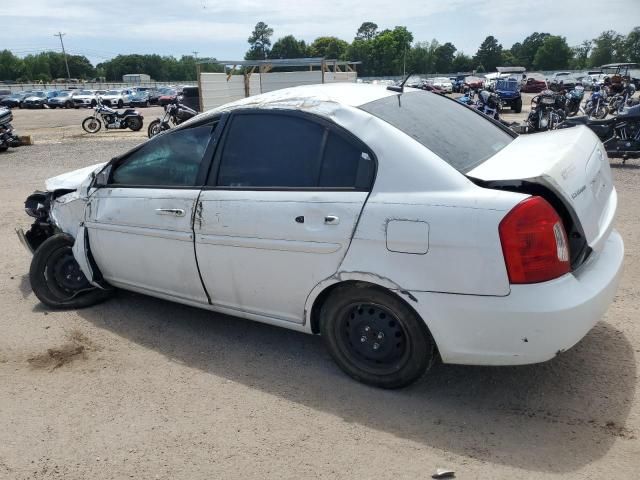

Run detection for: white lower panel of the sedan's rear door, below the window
[[195, 190, 367, 323]]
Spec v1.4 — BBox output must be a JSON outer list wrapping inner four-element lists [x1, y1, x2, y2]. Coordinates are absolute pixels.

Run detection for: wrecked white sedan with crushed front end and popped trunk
[[19, 84, 624, 388]]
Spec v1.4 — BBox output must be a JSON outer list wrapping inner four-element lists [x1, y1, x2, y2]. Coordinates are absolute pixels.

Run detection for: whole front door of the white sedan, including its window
[[85, 122, 213, 303]]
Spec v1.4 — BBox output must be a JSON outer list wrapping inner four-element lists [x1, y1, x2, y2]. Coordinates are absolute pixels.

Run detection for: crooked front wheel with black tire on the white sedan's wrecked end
[[29, 233, 112, 309]]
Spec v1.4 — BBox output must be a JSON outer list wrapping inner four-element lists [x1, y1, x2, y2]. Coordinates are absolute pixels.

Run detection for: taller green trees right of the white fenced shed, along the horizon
[[245, 22, 640, 76]]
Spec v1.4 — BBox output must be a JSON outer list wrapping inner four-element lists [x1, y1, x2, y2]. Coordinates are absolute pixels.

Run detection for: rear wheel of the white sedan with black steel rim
[[320, 283, 437, 388]]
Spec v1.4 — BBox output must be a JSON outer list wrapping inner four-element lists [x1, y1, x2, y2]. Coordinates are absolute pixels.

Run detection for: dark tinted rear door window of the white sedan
[[210, 112, 375, 190]]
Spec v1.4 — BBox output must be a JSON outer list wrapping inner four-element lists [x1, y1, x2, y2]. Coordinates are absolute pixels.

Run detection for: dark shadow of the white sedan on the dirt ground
[[69, 291, 636, 473]]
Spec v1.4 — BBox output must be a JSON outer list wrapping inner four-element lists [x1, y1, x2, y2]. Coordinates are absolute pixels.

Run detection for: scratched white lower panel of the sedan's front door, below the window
[[86, 188, 207, 303]]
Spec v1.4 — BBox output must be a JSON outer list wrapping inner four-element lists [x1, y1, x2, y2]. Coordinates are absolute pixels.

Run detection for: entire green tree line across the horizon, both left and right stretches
[[0, 22, 640, 82]]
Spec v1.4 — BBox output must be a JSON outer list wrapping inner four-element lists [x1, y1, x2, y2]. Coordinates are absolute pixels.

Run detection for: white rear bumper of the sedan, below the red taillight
[[411, 230, 624, 365]]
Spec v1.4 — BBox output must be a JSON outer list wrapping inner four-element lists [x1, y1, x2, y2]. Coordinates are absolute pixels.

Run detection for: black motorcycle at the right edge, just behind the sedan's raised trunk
[[558, 105, 640, 164]]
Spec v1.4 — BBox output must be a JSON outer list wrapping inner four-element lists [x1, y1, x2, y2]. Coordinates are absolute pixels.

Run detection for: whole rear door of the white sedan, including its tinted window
[[194, 110, 375, 323]]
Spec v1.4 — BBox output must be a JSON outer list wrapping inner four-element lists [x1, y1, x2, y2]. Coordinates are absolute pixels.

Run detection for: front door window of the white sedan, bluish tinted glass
[[110, 123, 214, 187]]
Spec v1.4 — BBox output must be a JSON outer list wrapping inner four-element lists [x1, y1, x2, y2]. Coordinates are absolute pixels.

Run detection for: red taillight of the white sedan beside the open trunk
[[499, 197, 570, 283]]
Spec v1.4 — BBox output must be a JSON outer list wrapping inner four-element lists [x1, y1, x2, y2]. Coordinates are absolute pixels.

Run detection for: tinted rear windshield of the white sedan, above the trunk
[[360, 91, 514, 173]]
